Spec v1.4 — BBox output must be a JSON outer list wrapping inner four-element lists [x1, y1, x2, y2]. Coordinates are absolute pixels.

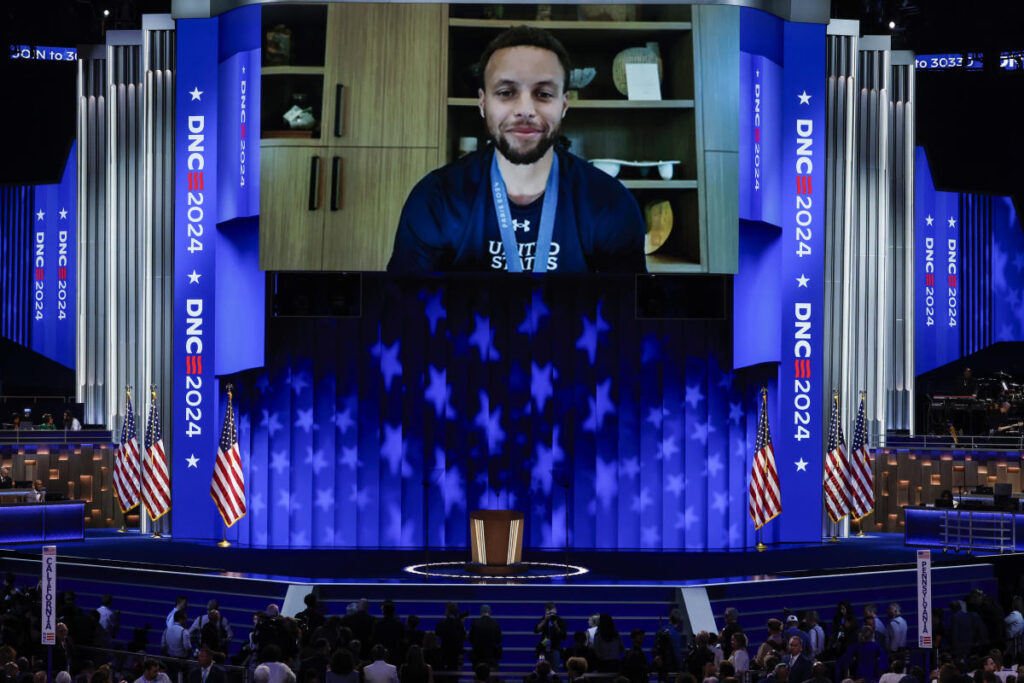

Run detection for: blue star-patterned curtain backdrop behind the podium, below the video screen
[[201, 274, 782, 549]]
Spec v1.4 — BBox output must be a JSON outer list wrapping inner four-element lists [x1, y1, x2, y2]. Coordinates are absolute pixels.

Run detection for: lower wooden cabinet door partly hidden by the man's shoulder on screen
[[324, 147, 437, 270]]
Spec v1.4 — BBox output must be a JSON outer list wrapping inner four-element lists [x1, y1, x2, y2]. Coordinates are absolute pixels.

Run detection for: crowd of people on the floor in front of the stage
[[0, 574, 1024, 683]]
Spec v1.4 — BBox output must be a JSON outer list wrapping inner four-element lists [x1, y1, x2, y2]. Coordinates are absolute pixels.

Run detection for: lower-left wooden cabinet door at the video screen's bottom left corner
[[259, 146, 329, 270]]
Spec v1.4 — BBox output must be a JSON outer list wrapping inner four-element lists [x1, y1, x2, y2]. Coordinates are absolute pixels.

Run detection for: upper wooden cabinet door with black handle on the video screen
[[324, 2, 446, 147]]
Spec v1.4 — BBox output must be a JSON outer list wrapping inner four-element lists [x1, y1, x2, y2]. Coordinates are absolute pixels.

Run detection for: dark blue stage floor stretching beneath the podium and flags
[[0, 529, 1007, 586]]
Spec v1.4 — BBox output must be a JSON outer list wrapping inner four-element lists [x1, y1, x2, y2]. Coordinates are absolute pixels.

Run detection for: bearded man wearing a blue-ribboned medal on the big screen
[[388, 26, 645, 272]]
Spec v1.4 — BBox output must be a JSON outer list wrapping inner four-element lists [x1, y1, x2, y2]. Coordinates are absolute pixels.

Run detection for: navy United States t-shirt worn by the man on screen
[[387, 147, 646, 272]]
